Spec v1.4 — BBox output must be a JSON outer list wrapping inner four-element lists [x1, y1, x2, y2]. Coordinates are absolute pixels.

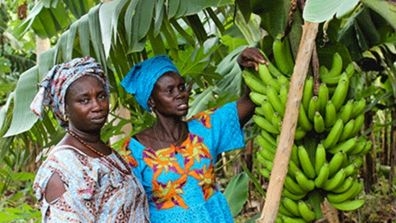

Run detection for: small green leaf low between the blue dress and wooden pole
[[224, 172, 249, 216]]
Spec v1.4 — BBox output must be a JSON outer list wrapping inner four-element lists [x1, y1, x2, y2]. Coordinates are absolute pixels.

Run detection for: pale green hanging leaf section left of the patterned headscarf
[[4, 67, 38, 137]]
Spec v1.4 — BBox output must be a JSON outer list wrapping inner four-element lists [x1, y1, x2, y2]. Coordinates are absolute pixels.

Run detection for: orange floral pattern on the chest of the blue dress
[[143, 134, 216, 209]]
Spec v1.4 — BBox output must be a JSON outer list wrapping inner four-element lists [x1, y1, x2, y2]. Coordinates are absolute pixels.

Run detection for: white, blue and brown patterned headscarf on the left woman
[[30, 56, 109, 126]]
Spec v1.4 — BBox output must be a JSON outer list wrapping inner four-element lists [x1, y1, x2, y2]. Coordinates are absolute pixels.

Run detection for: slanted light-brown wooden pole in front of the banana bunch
[[257, 21, 318, 223]]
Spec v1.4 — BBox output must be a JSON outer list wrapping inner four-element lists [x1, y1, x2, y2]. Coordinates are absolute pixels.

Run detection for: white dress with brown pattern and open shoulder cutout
[[33, 146, 149, 223]]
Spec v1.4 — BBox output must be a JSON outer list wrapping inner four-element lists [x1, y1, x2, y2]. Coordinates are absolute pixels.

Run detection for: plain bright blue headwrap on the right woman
[[121, 55, 179, 111]]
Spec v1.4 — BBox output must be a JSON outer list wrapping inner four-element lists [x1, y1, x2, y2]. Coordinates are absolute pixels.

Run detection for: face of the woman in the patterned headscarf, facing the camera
[[66, 76, 109, 132]]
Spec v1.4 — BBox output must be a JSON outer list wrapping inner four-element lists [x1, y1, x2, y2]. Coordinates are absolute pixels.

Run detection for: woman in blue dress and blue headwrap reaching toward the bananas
[[121, 48, 265, 223]]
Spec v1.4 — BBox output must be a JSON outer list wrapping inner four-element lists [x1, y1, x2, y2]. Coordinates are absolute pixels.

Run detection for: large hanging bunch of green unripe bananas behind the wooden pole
[[243, 39, 372, 222]]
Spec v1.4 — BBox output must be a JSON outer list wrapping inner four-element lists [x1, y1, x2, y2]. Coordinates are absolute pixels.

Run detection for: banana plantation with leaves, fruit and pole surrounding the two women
[[0, 0, 396, 223]]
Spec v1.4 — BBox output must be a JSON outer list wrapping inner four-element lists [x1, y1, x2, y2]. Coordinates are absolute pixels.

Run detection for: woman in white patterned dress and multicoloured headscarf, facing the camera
[[31, 57, 149, 223]]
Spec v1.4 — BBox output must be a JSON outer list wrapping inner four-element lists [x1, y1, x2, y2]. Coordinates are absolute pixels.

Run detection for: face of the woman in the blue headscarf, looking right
[[149, 72, 190, 117]]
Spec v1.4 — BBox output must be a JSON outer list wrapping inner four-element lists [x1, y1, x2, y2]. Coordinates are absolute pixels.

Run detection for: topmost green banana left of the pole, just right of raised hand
[[272, 35, 294, 76]]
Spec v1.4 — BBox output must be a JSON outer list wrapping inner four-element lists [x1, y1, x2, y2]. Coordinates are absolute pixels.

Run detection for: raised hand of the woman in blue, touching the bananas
[[237, 47, 266, 71]]
